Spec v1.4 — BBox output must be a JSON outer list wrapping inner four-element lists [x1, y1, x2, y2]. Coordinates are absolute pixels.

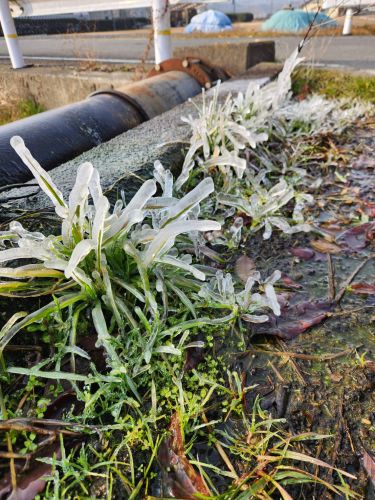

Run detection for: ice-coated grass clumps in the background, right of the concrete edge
[[174, 49, 373, 242]]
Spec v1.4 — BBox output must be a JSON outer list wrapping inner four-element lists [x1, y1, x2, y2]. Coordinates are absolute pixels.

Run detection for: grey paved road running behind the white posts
[[0, 32, 375, 71]]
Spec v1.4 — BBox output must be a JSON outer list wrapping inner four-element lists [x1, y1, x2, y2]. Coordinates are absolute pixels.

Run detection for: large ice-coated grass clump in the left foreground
[[0, 137, 277, 384]]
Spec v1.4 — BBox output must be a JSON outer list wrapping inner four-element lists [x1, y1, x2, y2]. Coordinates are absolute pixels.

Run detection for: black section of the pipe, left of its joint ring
[[0, 94, 143, 186]]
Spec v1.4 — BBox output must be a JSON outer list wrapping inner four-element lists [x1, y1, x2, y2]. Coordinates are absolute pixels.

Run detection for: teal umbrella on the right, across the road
[[262, 9, 337, 32]]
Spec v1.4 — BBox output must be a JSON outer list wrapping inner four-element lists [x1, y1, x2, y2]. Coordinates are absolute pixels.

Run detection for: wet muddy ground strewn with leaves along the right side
[[232, 123, 375, 498]]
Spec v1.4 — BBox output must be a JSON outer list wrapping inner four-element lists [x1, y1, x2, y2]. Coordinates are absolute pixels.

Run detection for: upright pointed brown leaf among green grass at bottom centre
[[158, 413, 211, 500]]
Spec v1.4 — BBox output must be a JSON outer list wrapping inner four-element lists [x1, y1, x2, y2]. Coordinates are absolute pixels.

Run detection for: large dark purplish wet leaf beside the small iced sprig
[[255, 302, 332, 340]]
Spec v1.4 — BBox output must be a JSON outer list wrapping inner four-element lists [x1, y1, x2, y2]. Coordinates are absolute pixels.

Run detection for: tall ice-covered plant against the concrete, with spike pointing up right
[[176, 50, 301, 190]]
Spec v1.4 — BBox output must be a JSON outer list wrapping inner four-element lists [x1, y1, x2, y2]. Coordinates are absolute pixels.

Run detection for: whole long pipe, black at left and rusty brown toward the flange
[[0, 71, 201, 186]]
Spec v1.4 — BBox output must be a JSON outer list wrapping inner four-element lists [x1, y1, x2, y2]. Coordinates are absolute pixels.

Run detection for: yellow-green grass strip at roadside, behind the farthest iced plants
[[292, 68, 375, 103]]
